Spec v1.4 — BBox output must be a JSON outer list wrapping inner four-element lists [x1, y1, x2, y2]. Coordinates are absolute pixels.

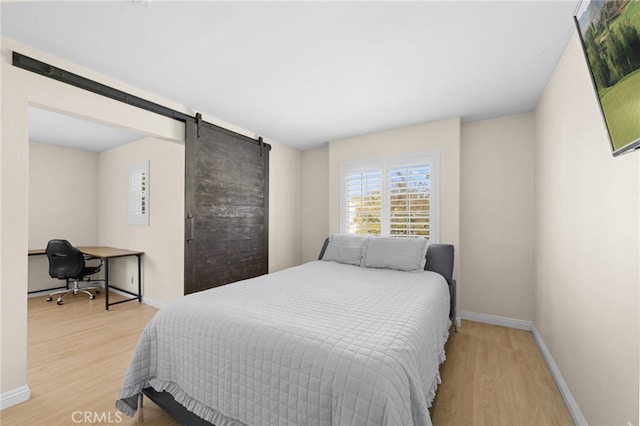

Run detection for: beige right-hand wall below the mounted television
[[534, 36, 640, 425]]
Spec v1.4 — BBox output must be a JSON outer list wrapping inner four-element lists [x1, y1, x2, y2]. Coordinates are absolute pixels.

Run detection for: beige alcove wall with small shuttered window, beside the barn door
[[98, 138, 184, 307]]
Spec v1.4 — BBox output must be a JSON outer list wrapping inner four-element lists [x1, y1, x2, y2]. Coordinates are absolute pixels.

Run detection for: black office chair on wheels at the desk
[[46, 240, 102, 305]]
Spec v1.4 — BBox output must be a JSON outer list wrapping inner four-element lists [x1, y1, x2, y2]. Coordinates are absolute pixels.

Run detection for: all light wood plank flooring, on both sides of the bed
[[0, 295, 572, 426]]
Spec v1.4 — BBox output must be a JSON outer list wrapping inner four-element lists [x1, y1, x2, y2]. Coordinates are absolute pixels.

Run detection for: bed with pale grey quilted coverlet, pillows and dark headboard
[[116, 235, 455, 426]]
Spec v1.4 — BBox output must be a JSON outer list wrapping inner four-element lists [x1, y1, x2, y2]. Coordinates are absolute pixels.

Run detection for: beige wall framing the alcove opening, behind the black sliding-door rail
[[0, 38, 184, 397]]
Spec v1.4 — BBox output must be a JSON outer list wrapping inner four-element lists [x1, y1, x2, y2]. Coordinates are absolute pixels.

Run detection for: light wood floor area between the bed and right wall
[[430, 321, 573, 426]]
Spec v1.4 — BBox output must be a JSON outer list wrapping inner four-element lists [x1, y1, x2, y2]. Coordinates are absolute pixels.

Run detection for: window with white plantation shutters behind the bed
[[341, 152, 439, 242]]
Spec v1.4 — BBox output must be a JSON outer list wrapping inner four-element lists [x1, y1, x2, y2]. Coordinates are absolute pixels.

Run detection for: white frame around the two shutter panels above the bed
[[340, 150, 440, 243]]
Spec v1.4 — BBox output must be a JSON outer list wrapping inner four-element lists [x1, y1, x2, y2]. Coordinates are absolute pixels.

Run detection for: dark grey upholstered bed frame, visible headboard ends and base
[[139, 238, 457, 426]]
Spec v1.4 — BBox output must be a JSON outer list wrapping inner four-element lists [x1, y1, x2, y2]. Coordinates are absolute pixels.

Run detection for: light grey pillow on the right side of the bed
[[362, 237, 429, 271]]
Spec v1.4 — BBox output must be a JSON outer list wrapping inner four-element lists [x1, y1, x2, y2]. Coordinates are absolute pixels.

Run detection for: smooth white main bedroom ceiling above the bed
[[1, 0, 577, 149]]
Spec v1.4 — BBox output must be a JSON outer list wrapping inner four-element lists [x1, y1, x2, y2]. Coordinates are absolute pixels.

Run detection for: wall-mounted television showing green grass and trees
[[574, 0, 640, 156]]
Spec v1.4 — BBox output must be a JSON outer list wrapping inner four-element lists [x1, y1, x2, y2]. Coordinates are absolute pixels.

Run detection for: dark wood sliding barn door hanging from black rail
[[184, 117, 271, 294]]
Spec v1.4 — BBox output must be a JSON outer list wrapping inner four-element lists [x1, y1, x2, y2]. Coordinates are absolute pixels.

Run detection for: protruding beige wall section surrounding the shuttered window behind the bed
[[329, 118, 460, 272]]
